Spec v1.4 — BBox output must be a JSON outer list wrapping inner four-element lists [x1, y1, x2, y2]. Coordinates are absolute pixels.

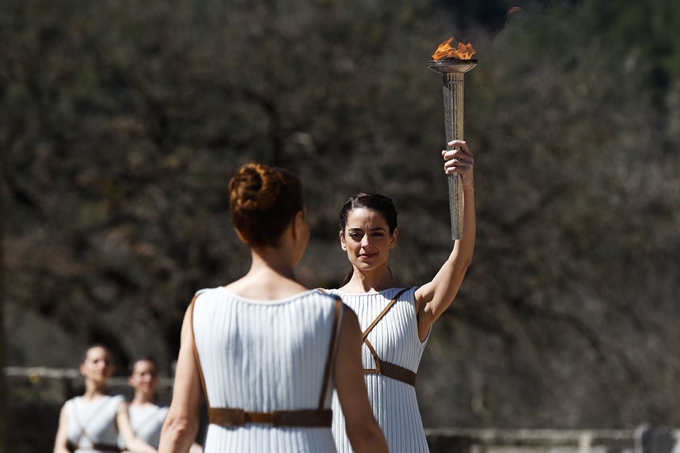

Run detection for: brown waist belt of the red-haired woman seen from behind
[[208, 407, 333, 428]]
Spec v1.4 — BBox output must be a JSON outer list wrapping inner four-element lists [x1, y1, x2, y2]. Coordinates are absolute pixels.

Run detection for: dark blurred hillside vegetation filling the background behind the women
[[0, 0, 680, 428]]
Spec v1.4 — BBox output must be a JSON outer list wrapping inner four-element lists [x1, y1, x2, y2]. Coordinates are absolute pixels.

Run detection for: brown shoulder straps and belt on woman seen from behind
[[189, 296, 342, 428]]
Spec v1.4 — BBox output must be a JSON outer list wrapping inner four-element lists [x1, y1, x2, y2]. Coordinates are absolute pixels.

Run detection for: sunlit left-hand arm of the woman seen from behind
[[158, 300, 201, 453]]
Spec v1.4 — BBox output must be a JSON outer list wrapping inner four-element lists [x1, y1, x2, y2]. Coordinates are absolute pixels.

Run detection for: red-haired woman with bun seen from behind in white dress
[[159, 164, 387, 453]]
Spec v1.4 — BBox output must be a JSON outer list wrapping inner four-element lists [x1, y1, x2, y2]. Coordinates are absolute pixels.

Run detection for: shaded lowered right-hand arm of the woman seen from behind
[[333, 307, 387, 453]]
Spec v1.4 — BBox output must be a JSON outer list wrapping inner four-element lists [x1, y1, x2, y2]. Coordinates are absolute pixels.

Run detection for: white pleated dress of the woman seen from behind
[[193, 287, 342, 453]]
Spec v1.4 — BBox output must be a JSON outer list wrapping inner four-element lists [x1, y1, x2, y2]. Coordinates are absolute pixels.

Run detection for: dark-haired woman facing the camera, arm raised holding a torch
[[327, 140, 475, 453]]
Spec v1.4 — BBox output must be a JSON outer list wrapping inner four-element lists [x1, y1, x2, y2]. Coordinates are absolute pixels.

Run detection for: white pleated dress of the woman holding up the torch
[[327, 287, 430, 453]]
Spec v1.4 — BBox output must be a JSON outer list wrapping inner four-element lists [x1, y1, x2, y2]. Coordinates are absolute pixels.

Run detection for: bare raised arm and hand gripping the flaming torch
[[415, 140, 476, 341]]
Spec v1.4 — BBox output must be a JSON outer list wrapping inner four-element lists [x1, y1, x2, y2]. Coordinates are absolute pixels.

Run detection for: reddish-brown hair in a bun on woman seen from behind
[[229, 163, 304, 246]]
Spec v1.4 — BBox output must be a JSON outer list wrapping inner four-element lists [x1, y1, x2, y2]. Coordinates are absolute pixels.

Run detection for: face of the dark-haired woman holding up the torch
[[340, 208, 398, 271]]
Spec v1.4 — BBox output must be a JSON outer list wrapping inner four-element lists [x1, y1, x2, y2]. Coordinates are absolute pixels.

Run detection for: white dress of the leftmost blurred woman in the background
[[64, 395, 124, 453]]
